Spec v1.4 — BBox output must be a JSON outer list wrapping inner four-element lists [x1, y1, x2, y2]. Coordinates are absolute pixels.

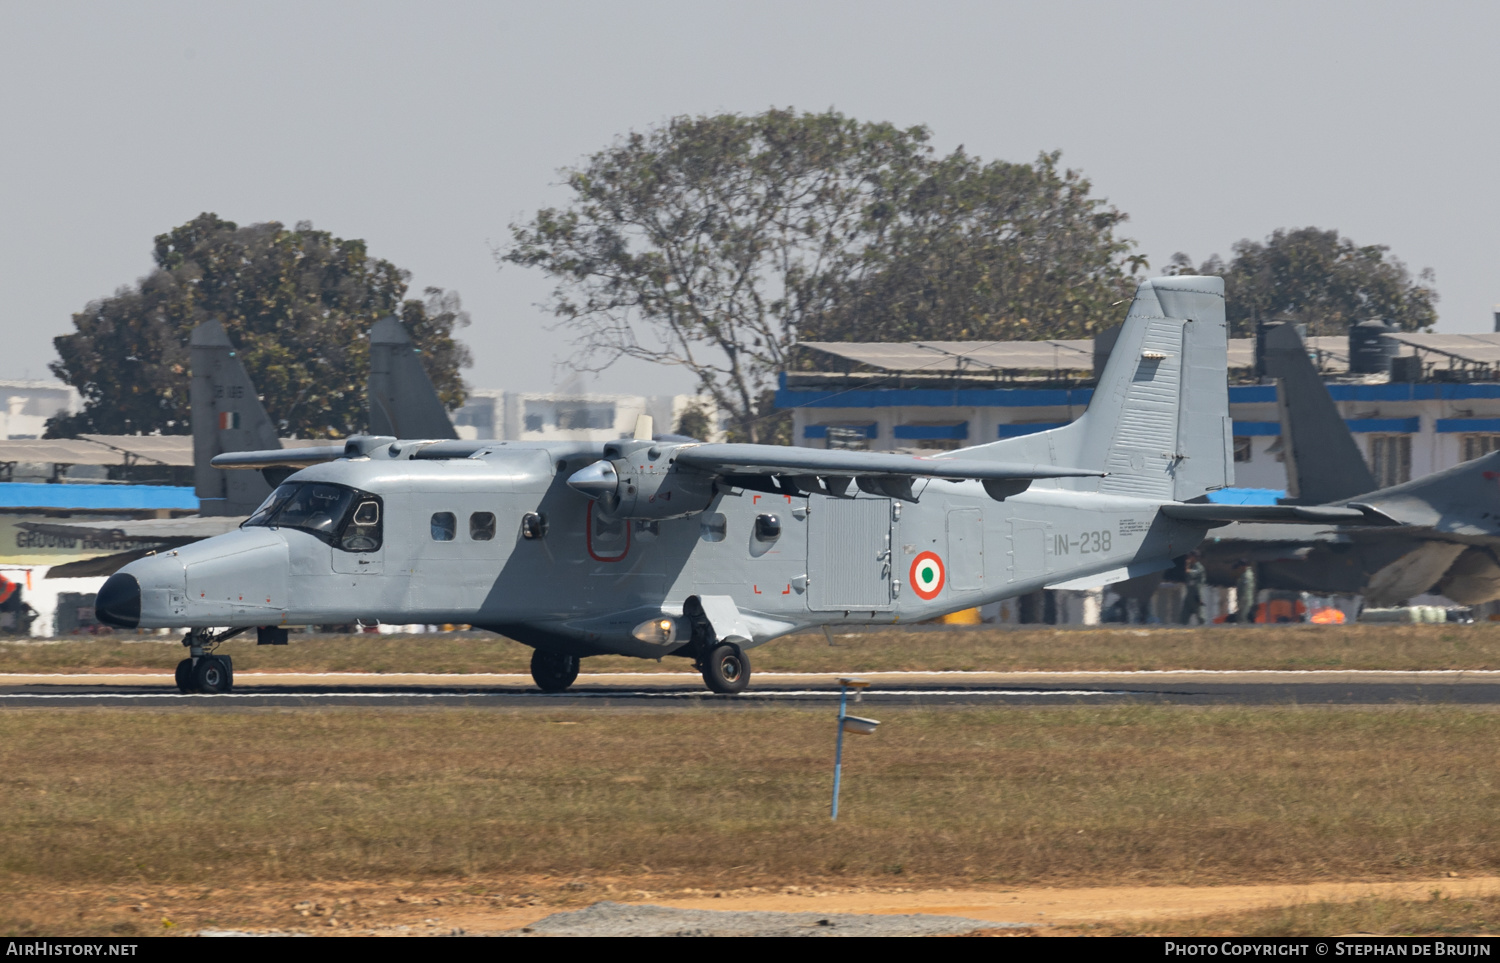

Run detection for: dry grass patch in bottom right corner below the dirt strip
[[1070, 888, 1500, 936]]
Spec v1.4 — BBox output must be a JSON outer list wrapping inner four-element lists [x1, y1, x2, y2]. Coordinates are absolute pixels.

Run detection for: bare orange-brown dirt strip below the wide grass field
[[14, 876, 1500, 936]]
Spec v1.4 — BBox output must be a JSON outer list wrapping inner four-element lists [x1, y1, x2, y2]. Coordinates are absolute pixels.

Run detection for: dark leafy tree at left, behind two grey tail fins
[[48, 213, 470, 438]]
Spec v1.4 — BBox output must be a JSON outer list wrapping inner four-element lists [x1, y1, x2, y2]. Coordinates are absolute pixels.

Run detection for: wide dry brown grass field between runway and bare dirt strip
[[0, 707, 1500, 933]]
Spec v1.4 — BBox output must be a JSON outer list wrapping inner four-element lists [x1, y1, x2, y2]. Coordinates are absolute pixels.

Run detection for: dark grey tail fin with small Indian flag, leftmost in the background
[[189, 321, 281, 515]]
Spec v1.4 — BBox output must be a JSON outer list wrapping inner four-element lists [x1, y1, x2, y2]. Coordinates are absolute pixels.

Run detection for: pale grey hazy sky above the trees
[[0, 0, 1500, 393]]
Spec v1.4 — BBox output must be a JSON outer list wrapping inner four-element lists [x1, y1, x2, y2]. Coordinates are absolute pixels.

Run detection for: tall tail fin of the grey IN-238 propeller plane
[[954, 276, 1235, 501]]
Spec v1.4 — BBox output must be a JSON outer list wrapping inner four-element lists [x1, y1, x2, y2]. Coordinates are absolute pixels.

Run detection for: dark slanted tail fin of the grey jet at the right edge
[[1262, 324, 1376, 506]]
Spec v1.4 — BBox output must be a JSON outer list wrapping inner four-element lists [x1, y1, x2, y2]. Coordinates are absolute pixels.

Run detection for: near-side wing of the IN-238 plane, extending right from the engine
[[675, 444, 1106, 500]]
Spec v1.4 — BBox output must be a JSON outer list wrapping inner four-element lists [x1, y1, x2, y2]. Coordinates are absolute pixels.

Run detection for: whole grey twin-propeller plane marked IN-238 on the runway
[[96, 276, 1368, 693]]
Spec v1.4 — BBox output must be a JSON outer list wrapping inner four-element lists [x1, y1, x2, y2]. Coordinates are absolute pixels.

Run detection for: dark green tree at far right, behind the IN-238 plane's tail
[[1169, 228, 1437, 338]]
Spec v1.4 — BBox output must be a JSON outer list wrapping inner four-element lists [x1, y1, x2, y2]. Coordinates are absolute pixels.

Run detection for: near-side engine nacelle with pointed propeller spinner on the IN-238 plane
[[567, 441, 714, 519]]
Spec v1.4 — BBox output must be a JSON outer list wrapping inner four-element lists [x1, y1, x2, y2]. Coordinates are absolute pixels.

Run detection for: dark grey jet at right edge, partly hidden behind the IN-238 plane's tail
[[1200, 324, 1500, 606]]
